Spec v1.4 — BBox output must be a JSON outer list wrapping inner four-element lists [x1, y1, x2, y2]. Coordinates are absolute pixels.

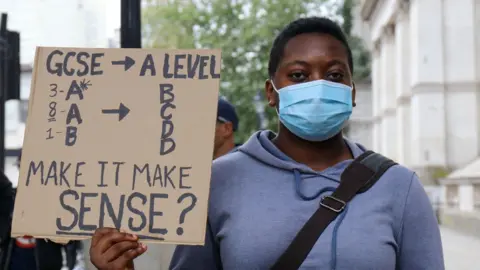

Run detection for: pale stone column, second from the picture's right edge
[[409, 0, 447, 184]]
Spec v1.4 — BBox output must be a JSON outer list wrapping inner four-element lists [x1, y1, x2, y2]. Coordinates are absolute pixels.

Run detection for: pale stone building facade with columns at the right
[[357, 0, 480, 185]]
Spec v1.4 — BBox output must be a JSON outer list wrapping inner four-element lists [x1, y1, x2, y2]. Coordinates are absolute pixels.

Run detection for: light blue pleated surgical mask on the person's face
[[272, 80, 352, 142]]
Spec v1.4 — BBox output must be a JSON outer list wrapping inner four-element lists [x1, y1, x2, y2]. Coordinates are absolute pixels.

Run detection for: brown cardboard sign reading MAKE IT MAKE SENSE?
[[12, 48, 221, 245]]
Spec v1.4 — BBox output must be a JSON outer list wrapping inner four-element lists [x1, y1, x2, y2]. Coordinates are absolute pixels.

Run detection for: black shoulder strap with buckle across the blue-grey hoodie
[[271, 151, 396, 270]]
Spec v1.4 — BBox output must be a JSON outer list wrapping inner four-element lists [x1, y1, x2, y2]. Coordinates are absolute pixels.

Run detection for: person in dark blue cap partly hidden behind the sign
[[213, 98, 238, 159]]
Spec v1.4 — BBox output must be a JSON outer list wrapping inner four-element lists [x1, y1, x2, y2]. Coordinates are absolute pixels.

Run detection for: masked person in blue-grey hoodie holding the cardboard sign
[[91, 17, 444, 270]]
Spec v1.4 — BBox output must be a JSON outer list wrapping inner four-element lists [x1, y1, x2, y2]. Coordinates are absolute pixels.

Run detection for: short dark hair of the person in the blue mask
[[268, 17, 353, 78]]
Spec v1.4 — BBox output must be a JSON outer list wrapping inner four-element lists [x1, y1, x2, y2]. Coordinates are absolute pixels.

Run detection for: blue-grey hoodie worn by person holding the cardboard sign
[[170, 131, 444, 270]]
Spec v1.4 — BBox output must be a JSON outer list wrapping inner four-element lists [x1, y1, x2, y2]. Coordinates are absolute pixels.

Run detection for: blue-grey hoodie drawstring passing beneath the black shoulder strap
[[293, 169, 348, 270]]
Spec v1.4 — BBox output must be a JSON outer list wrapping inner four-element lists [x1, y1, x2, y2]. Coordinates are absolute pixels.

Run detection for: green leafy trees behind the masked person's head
[[142, 0, 369, 142]]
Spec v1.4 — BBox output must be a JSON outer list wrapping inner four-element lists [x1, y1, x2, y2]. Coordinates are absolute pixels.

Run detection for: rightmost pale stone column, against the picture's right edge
[[441, 0, 480, 168]]
